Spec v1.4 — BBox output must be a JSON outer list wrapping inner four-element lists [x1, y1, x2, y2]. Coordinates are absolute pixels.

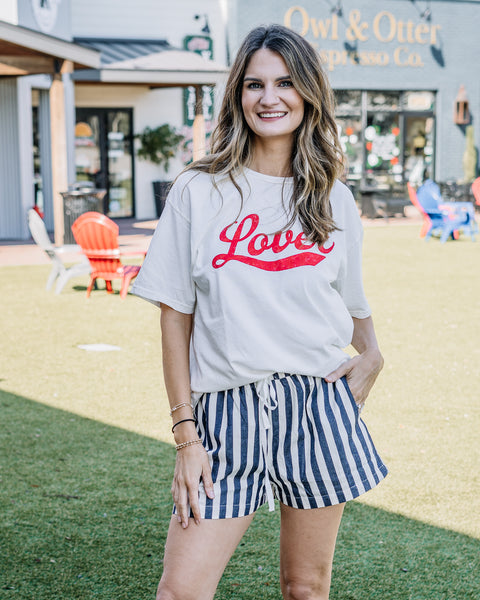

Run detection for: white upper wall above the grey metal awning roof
[[72, 0, 226, 63]]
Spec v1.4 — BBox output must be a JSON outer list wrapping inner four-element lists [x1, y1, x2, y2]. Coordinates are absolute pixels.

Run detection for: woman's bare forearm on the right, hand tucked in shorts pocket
[[325, 317, 383, 406]]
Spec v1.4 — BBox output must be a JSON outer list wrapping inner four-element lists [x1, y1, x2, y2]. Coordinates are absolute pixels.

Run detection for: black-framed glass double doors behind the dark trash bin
[[75, 108, 135, 217]]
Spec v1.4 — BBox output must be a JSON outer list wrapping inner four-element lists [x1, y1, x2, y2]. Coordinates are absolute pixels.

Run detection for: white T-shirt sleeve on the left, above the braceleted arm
[[132, 181, 195, 314]]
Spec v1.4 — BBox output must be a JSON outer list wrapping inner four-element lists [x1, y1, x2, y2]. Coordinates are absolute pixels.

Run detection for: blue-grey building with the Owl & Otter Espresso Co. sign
[[230, 0, 480, 191]]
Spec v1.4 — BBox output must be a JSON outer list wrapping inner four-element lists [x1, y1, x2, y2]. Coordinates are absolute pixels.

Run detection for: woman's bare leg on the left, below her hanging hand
[[157, 515, 253, 600]]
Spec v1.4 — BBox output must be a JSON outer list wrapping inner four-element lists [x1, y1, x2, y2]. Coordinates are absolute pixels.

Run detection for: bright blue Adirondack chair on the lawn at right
[[417, 179, 477, 244]]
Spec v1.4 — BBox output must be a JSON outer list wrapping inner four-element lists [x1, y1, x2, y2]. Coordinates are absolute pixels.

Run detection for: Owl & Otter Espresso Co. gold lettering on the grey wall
[[283, 6, 441, 71]]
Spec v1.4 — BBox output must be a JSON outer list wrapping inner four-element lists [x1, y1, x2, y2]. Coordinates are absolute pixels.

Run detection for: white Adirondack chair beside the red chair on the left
[[28, 208, 91, 294]]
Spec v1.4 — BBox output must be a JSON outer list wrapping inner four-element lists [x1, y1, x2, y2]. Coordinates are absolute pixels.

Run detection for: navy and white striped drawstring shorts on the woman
[[178, 373, 387, 519]]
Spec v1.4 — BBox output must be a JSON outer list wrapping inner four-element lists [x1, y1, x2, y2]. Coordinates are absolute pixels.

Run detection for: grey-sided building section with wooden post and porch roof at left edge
[[0, 0, 100, 239]]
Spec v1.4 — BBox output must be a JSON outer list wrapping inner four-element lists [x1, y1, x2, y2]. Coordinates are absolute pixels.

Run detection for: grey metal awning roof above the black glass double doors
[[73, 38, 228, 87]]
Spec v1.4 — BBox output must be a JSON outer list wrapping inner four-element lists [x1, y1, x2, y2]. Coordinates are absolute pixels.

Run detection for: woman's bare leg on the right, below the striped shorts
[[280, 504, 345, 600]]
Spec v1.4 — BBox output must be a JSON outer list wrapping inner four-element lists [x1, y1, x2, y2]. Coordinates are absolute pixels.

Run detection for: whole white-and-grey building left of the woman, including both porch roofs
[[0, 0, 226, 239]]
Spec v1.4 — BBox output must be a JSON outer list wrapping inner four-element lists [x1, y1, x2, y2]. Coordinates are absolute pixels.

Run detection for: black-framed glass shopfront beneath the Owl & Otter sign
[[335, 90, 436, 190]]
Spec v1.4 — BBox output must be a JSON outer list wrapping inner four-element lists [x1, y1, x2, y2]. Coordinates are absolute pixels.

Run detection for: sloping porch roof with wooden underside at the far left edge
[[0, 21, 100, 76]]
